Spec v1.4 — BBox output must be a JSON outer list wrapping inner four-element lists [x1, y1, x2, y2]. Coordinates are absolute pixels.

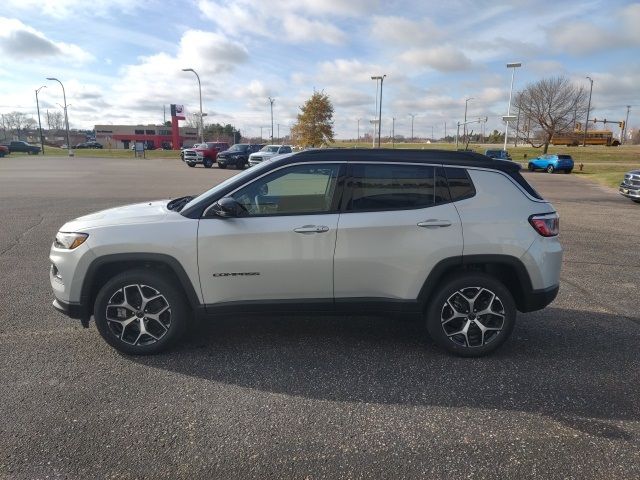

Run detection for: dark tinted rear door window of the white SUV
[[347, 164, 435, 211]]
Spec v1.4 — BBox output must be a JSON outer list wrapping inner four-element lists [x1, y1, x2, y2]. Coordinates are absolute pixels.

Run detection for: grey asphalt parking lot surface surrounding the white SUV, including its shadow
[[0, 157, 640, 479]]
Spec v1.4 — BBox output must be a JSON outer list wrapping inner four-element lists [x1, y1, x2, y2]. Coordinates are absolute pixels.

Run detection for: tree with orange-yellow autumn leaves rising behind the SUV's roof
[[291, 91, 334, 147]]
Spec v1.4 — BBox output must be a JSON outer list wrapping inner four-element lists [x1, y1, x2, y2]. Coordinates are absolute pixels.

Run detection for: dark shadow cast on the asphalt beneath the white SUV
[[133, 308, 640, 439]]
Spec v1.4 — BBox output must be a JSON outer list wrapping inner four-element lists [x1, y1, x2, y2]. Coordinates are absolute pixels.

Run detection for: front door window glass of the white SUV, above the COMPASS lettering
[[231, 163, 340, 216]]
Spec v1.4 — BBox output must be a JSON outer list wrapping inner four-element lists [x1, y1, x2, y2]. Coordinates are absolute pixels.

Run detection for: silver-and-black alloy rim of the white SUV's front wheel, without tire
[[105, 284, 171, 345]]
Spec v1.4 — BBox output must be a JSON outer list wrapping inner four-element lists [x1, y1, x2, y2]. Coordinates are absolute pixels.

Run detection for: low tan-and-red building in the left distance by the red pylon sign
[[95, 125, 198, 150]]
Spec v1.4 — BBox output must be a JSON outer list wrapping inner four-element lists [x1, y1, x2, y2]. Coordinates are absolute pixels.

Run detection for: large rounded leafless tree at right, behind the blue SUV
[[515, 77, 588, 153]]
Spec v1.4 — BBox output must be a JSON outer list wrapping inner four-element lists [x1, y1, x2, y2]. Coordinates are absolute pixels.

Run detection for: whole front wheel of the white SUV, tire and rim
[[93, 269, 189, 355]]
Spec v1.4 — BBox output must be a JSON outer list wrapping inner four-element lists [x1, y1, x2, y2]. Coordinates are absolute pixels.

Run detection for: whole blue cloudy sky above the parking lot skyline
[[0, 0, 640, 138]]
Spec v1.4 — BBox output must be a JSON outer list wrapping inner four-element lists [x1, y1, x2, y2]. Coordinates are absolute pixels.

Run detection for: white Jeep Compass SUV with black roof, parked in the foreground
[[50, 149, 562, 356]]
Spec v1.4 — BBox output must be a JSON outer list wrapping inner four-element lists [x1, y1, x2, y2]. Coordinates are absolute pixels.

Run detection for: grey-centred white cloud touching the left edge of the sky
[[0, 17, 93, 63]]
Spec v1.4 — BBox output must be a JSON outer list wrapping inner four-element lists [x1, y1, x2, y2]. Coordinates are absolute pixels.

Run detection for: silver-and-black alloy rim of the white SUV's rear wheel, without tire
[[440, 287, 506, 347]]
